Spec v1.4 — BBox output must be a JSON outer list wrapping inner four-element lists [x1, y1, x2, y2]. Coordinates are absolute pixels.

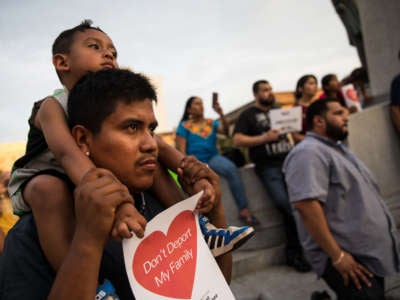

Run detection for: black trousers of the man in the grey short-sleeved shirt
[[322, 257, 385, 300]]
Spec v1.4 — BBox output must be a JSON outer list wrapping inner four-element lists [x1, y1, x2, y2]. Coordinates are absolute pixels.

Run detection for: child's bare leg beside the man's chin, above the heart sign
[[151, 164, 186, 207]]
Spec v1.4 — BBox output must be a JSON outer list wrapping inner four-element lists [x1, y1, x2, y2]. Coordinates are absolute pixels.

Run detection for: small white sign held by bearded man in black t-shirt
[[269, 106, 302, 134]]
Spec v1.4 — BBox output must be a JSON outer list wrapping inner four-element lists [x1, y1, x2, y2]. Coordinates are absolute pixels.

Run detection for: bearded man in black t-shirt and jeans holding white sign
[[233, 80, 310, 272]]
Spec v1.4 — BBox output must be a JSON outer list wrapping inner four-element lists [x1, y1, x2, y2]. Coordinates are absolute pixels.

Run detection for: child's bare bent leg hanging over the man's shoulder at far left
[[23, 174, 75, 270]]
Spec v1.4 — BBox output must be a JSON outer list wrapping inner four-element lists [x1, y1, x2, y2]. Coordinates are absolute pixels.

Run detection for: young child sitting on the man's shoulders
[[9, 21, 254, 270]]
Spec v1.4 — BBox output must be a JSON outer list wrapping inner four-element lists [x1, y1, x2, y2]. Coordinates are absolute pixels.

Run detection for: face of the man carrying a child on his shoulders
[[89, 99, 158, 192]]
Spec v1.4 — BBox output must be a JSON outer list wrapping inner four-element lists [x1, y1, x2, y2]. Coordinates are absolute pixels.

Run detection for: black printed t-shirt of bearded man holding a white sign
[[234, 106, 293, 167]]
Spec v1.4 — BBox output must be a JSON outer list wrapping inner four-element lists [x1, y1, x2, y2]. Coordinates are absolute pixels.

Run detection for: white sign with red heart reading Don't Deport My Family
[[123, 193, 235, 300]]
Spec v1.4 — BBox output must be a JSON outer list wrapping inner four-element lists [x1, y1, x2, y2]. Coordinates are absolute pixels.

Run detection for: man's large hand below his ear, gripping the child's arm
[[74, 168, 133, 246]]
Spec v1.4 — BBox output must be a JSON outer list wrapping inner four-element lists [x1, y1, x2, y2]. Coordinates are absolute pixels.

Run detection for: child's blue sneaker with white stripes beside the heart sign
[[199, 216, 254, 257]]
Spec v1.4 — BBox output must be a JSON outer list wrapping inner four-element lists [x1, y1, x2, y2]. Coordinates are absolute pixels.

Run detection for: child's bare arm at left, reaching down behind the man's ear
[[34, 98, 95, 185]]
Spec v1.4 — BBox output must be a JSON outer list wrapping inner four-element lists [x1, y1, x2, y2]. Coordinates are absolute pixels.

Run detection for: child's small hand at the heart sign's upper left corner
[[111, 203, 147, 240]]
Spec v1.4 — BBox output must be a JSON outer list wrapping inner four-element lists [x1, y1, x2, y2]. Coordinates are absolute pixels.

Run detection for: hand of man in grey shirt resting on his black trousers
[[333, 251, 373, 290]]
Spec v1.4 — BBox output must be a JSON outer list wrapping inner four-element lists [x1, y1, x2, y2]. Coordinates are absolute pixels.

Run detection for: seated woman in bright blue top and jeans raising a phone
[[175, 93, 259, 226]]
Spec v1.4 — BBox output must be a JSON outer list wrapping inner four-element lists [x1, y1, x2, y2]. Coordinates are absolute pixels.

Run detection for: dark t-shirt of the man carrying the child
[[0, 193, 163, 300]]
